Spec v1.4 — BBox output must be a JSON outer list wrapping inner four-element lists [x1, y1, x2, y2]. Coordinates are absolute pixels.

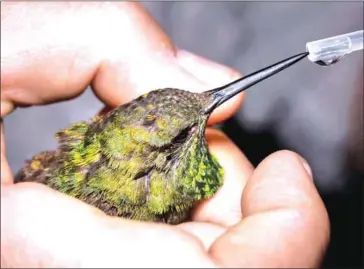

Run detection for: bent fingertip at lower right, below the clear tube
[[210, 151, 329, 268]]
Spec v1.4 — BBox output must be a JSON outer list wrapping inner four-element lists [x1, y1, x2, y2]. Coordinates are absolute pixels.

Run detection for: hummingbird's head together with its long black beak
[[103, 53, 308, 160]]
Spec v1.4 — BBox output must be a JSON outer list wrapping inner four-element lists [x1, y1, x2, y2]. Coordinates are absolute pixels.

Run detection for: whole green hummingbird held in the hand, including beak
[[15, 53, 308, 225]]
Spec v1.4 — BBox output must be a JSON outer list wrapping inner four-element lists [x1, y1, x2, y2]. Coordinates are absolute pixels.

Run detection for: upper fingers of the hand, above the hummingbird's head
[[1, 2, 243, 123]]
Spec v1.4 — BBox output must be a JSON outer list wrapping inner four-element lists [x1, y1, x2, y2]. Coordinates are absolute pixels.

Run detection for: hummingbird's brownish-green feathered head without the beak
[[116, 88, 212, 147]]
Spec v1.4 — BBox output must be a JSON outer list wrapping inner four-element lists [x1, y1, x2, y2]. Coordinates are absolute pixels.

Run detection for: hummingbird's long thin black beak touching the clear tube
[[205, 52, 309, 114]]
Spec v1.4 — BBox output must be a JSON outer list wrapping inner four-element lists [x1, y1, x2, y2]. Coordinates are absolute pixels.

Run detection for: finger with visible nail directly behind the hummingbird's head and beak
[[93, 50, 245, 125]]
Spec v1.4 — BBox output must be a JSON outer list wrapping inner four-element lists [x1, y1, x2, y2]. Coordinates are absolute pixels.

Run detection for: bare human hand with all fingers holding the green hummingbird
[[1, 2, 329, 268]]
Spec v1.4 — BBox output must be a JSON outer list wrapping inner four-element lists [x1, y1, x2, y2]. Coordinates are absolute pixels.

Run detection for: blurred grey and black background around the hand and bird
[[5, 2, 364, 268]]
